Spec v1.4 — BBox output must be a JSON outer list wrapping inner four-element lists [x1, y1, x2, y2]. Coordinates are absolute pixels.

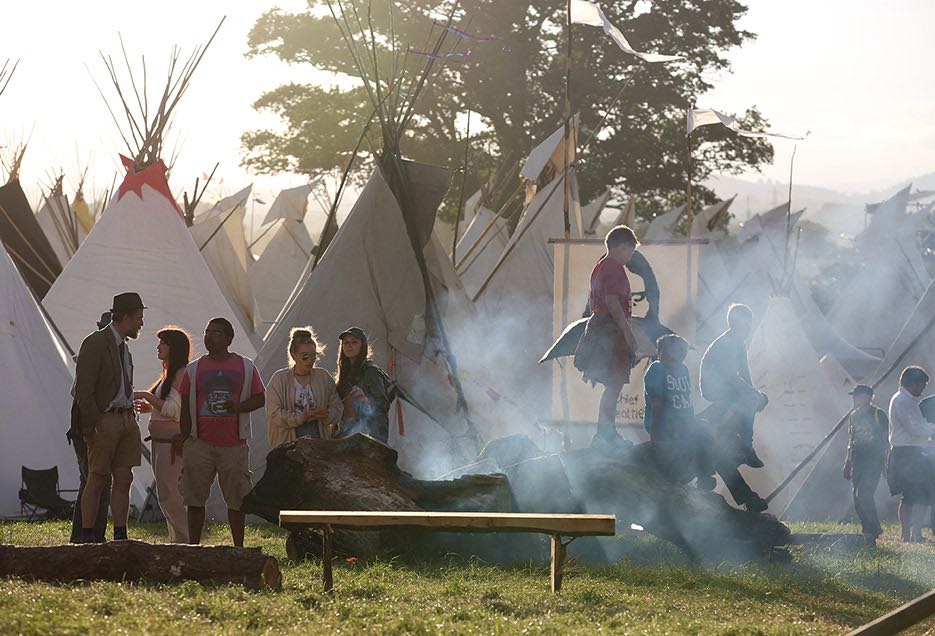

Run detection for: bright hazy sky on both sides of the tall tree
[[0, 0, 935, 209]]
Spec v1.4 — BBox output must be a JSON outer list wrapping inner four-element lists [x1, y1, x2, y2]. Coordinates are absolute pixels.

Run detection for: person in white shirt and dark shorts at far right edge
[[886, 366, 935, 543]]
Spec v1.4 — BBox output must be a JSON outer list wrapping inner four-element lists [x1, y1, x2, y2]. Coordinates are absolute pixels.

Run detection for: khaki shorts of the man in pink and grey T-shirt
[[179, 439, 253, 510]]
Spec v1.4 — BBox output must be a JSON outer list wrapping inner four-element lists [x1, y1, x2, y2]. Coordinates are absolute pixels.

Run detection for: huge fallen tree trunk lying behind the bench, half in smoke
[[244, 435, 790, 561]]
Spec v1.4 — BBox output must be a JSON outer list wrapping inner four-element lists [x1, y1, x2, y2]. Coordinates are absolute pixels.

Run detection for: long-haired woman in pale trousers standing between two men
[[133, 327, 191, 543]]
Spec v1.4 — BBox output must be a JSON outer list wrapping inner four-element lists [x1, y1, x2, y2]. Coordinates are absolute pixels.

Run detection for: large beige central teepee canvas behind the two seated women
[[251, 164, 486, 476]]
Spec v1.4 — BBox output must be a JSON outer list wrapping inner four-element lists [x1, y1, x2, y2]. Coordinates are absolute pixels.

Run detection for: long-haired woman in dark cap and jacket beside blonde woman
[[338, 327, 393, 444]]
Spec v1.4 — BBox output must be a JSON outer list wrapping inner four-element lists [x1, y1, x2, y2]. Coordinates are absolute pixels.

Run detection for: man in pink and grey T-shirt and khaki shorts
[[176, 318, 266, 547]]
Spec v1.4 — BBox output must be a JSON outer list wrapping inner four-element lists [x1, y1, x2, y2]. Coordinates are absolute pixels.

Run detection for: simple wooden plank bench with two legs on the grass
[[279, 510, 616, 592]]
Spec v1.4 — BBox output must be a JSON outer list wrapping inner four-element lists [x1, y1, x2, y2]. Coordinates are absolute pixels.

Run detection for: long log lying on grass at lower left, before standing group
[[0, 541, 282, 590]]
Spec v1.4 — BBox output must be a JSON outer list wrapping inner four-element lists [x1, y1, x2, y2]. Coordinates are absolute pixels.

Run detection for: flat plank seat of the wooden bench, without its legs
[[279, 510, 616, 537]]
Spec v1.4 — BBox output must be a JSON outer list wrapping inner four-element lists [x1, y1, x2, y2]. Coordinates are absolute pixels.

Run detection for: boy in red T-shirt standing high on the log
[[575, 225, 639, 447]]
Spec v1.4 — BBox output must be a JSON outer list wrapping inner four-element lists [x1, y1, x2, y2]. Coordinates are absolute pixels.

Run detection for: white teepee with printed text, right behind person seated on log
[[742, 296, 852, 512]]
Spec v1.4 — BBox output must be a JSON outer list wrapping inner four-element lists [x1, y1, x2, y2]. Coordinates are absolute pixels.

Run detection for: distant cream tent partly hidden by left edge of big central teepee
[[250, 219, 315, 334]]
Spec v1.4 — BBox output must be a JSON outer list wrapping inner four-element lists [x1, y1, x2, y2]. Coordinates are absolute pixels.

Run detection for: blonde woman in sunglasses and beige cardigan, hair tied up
[[266, 327, 344, 448]]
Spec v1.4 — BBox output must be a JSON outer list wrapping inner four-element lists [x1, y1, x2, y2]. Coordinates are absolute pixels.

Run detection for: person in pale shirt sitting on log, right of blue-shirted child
[[699, 304, 769, 468]]
